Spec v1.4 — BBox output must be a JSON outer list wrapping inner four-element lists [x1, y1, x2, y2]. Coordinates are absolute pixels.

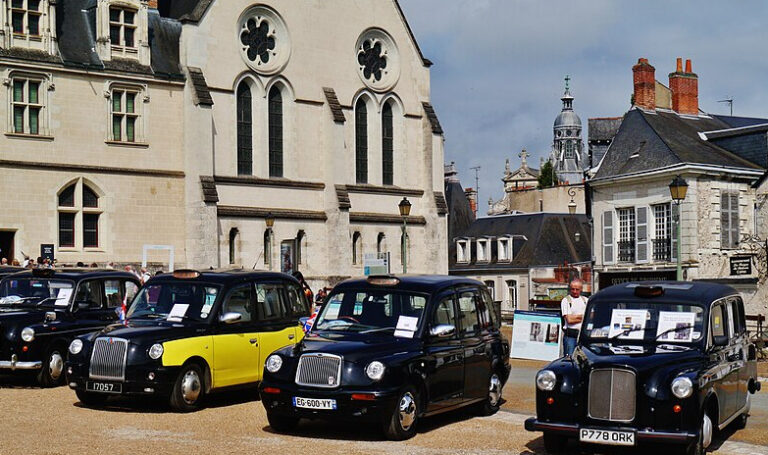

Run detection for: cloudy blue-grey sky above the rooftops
[[400, 0, 768, 210]]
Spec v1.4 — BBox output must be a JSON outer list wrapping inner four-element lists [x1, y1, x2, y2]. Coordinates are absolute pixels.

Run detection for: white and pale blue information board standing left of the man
[[509, 311, 562, 360]]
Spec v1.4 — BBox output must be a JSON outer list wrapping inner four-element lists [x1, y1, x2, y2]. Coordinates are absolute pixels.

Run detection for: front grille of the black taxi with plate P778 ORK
[[588, 368, 637, 422]]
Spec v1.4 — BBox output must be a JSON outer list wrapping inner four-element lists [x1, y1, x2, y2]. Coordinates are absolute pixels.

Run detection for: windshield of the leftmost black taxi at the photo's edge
[[0, 278, 74, 307]]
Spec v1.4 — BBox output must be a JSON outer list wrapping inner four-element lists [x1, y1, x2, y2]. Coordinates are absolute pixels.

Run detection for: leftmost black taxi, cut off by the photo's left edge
[[0, 269, 140, 387]]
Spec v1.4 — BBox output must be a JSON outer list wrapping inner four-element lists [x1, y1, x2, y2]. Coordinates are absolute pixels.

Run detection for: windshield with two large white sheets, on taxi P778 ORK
[[583, 301, 704, 344]]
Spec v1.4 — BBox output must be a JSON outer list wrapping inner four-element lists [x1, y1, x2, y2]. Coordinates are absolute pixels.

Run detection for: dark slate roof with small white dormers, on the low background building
[[449, 213, 592, 273]]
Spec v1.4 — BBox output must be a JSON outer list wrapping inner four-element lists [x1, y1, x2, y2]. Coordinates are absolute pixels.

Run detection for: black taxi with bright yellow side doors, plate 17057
[[66, 270, 309, 411]]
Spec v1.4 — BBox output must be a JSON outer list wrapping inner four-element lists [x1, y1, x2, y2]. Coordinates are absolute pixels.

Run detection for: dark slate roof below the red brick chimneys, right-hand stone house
[[595, 109, 768, 179]]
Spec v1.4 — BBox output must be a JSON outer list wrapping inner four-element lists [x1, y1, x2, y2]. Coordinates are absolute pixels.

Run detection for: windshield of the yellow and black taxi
[[127, 282, 220, 322]]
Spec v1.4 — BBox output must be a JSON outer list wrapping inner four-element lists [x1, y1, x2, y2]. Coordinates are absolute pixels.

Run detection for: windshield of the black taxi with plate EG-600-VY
[[313, 289, 427, 338]]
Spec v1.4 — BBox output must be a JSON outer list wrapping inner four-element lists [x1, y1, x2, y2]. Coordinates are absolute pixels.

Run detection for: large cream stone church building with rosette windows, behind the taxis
[[0, 0, 448, 282]]
